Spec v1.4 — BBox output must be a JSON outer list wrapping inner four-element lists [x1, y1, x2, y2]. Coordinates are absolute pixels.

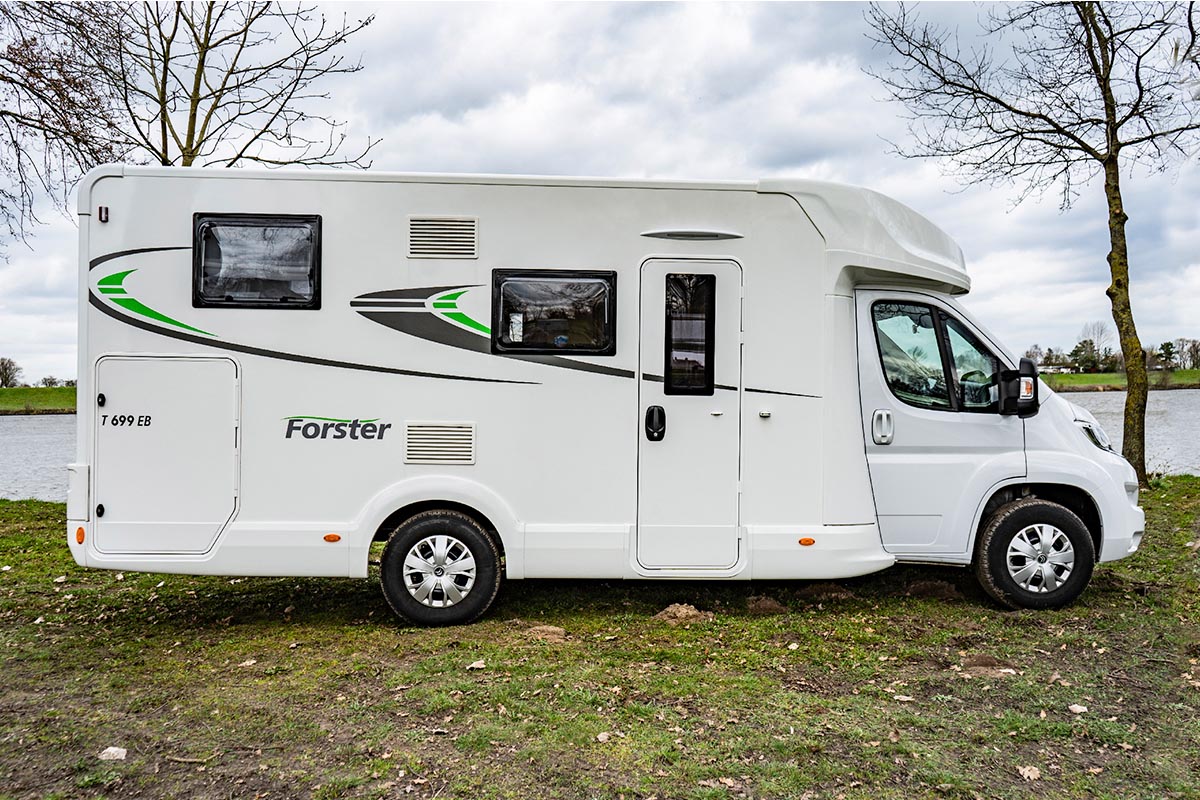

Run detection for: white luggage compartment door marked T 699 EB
[[92, 356, 240, 553]]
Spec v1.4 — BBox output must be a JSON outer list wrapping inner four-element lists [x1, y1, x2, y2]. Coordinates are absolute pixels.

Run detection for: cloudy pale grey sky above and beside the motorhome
[[0, 2, 1200, 383]]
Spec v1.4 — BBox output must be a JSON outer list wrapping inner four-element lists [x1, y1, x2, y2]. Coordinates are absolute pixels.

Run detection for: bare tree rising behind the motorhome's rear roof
[[96, 2, 376, 167]]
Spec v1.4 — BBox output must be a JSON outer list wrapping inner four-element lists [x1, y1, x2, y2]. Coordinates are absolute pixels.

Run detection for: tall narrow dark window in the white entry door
[[664, 275, 716, 395]]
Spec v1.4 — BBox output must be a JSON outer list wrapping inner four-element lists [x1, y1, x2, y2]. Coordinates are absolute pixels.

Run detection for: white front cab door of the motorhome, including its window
[[857, 290, 1025, 557]]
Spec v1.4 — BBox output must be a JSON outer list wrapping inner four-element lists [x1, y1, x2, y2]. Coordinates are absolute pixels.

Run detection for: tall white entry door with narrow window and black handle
[[637, 259, 742, 569]]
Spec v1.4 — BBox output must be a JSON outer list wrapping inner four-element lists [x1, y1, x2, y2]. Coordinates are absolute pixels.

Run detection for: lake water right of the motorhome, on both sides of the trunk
[[1063, 389, 1200, 475]]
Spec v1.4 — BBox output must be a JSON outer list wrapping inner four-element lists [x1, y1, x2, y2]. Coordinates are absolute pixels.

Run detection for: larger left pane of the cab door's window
[[871, 302, 952, 409]]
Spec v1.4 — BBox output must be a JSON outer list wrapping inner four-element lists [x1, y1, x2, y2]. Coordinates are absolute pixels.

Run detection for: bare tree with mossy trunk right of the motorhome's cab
[[868, 2, 1200, 485]]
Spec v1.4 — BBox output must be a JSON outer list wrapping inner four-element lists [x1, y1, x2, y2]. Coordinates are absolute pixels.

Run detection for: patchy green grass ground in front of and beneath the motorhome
[[0, 477, 1200, 800]]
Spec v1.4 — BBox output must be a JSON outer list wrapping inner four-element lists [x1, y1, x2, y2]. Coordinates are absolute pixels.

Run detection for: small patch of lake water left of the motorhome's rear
[[0, 414, 76, 503]]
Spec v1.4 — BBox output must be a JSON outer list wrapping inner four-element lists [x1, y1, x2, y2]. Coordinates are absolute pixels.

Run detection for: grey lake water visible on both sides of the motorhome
[[0, 389, 1200, 503]]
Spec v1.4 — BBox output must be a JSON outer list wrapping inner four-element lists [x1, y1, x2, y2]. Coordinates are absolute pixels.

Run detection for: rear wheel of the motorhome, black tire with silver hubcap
[[379, 510, 500, 626]]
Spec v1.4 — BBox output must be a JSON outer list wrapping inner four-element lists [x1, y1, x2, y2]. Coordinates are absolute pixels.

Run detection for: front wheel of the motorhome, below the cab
[[974, 498, 1096, 609]]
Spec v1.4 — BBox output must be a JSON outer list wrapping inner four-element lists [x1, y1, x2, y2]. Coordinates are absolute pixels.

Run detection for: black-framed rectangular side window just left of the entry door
[[492, 270, 617, 355]]
